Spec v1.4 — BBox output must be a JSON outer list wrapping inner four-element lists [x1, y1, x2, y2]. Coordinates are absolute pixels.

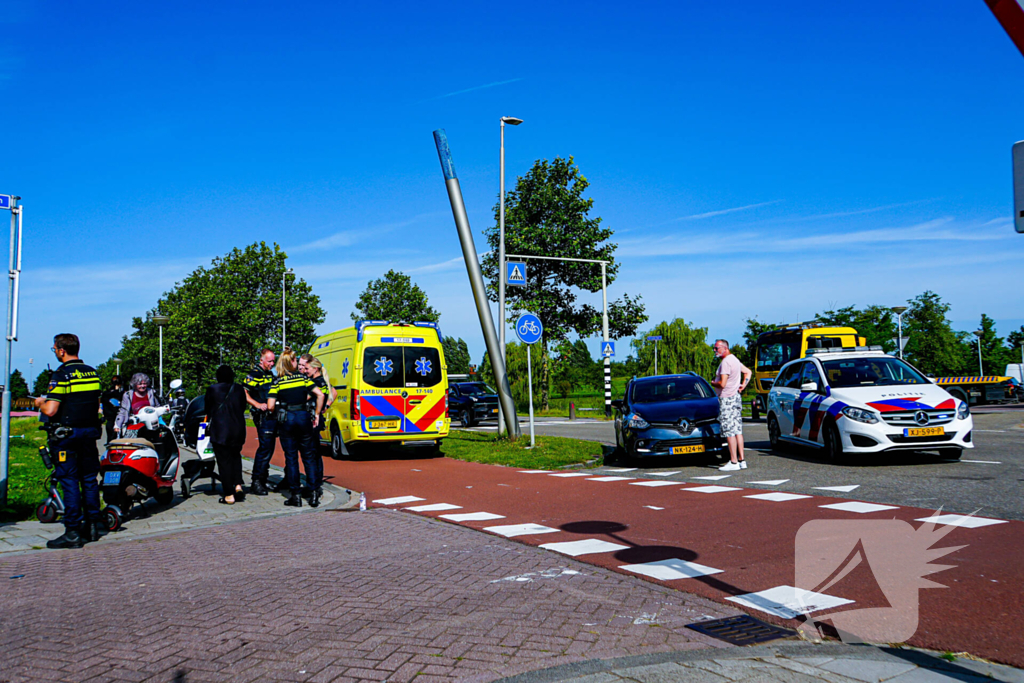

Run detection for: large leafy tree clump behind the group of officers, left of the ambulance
[[109, 243, 325, 395]]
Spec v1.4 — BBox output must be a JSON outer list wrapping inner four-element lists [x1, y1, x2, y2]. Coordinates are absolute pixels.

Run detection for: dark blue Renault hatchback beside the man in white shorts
[[611, 373, 727, 459]]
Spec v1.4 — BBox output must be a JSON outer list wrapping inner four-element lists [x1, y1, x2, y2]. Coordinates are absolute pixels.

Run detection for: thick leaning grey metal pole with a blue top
[[434, 128, 519, 439]]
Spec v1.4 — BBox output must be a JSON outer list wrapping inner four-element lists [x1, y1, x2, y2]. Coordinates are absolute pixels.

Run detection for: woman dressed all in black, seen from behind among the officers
[[206, 366, 246, 505]]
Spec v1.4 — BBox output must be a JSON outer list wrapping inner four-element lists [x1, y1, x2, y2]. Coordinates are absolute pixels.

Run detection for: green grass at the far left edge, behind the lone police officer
[[0, 418, 47, 522]]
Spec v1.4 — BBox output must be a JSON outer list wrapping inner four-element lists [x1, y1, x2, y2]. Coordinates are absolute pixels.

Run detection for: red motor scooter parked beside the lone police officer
[[99, 405, 180, 531]]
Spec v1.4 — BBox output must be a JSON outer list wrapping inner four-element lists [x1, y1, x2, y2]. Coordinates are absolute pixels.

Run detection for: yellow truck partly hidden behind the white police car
[[751, 321, 866, 420]]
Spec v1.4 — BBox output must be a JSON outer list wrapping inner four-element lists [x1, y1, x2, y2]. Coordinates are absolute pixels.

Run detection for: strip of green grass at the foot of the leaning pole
[[441, 430, 604, 470]]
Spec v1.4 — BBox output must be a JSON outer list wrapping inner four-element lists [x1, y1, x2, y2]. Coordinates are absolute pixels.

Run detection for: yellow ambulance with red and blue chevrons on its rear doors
[[309, 321, 451, 458]]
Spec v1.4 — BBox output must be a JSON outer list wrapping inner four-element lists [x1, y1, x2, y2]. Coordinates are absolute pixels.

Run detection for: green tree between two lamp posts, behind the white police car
[[903, 291, 966, 377]]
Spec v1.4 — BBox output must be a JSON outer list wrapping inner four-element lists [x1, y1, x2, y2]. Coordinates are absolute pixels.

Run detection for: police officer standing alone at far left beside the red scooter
[[36, 334, 106, 548]]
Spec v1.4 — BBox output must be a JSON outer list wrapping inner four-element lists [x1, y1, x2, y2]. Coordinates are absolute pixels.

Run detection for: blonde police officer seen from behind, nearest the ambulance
[[267, 348, 324, 508]]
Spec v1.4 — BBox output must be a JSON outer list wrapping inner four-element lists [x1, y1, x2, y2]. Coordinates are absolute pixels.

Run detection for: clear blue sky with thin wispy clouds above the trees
[[0, 2, 1024, 385]]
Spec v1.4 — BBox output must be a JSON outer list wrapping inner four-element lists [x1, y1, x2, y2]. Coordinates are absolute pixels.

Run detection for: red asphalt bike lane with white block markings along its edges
[[244, 429, 1024, 667]]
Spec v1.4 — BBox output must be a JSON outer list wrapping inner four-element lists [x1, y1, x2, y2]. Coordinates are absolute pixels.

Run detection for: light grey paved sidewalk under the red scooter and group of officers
[[0, 449, 358, 552]]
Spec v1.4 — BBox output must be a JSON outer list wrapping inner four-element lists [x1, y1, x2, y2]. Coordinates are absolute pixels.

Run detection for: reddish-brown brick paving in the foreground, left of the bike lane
[[0, 509, 737, 683]]
